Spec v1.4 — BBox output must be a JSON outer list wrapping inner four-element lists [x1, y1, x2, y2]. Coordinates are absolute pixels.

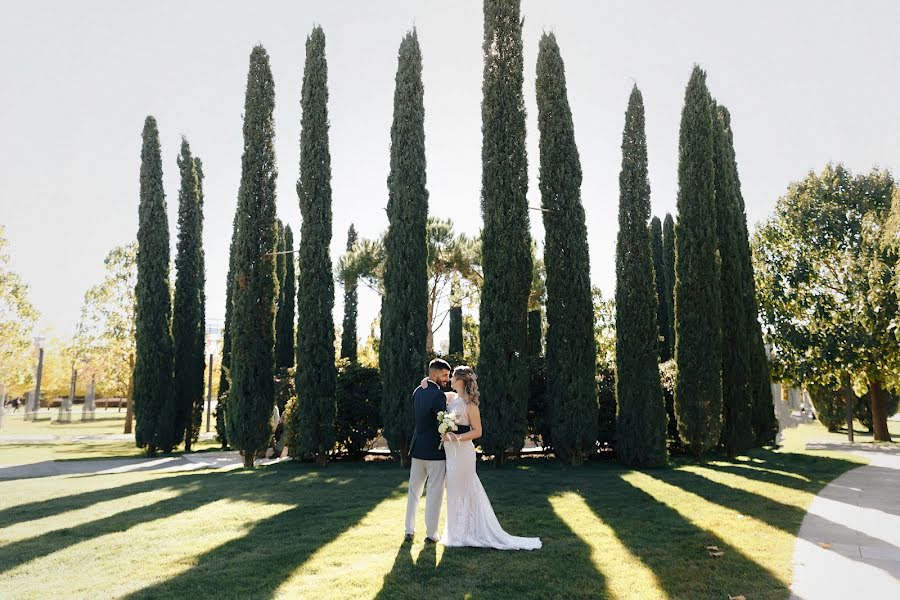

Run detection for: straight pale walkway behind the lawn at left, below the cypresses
[[0, 451, 290, 480]]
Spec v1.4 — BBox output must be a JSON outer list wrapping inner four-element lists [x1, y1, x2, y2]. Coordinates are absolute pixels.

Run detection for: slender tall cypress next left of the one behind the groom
[[295, 27, 337, 464]]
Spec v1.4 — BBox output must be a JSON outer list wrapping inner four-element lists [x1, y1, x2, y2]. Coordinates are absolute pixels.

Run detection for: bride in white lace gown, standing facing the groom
[[424, 366, 541, 550]]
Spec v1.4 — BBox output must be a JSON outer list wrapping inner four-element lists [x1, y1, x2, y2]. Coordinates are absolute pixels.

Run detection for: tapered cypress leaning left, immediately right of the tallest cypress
[[536, 33, 596, 464]]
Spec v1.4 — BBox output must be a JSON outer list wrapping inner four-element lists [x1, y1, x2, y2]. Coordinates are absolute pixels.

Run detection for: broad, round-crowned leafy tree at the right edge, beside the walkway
[[754, 164, 900, 441]]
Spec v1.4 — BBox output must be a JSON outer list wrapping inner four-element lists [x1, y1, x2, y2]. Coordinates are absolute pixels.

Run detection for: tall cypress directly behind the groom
[[379, 30, 428, 465]]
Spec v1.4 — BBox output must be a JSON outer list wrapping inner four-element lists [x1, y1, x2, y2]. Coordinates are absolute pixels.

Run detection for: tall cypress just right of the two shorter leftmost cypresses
[[226, 46, 278, 467]]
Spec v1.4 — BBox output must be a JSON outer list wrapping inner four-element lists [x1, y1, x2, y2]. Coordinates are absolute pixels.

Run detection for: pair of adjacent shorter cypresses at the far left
[[133, 116, 206, 456]]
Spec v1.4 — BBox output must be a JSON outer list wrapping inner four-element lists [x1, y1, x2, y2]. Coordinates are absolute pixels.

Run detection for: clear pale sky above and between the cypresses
[[0, 0, 900, 341]]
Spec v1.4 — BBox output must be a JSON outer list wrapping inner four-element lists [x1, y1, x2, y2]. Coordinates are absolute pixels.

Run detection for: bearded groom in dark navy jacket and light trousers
[[405, 358, 450, 543]]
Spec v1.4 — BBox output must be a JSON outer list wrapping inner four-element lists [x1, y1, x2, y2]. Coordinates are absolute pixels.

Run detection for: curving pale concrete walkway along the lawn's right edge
[[791, 443, 900, 600]]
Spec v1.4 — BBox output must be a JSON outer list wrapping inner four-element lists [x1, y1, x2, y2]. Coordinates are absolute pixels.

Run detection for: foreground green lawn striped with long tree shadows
[[0, 422, 880, 599]]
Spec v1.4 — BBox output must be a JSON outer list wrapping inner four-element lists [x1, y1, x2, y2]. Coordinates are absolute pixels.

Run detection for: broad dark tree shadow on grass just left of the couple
[[126, 465, 400, 598]]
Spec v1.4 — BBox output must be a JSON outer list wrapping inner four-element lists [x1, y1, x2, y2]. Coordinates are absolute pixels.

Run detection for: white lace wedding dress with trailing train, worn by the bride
[[441, 394, 541, 550]]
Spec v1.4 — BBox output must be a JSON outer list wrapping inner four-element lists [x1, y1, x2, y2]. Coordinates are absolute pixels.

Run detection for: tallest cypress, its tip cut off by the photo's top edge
[[478, 0, 532, 465]]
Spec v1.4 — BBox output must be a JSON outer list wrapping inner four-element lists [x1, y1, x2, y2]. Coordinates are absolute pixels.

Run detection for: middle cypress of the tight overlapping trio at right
[[713, 105, 753, 456]]
